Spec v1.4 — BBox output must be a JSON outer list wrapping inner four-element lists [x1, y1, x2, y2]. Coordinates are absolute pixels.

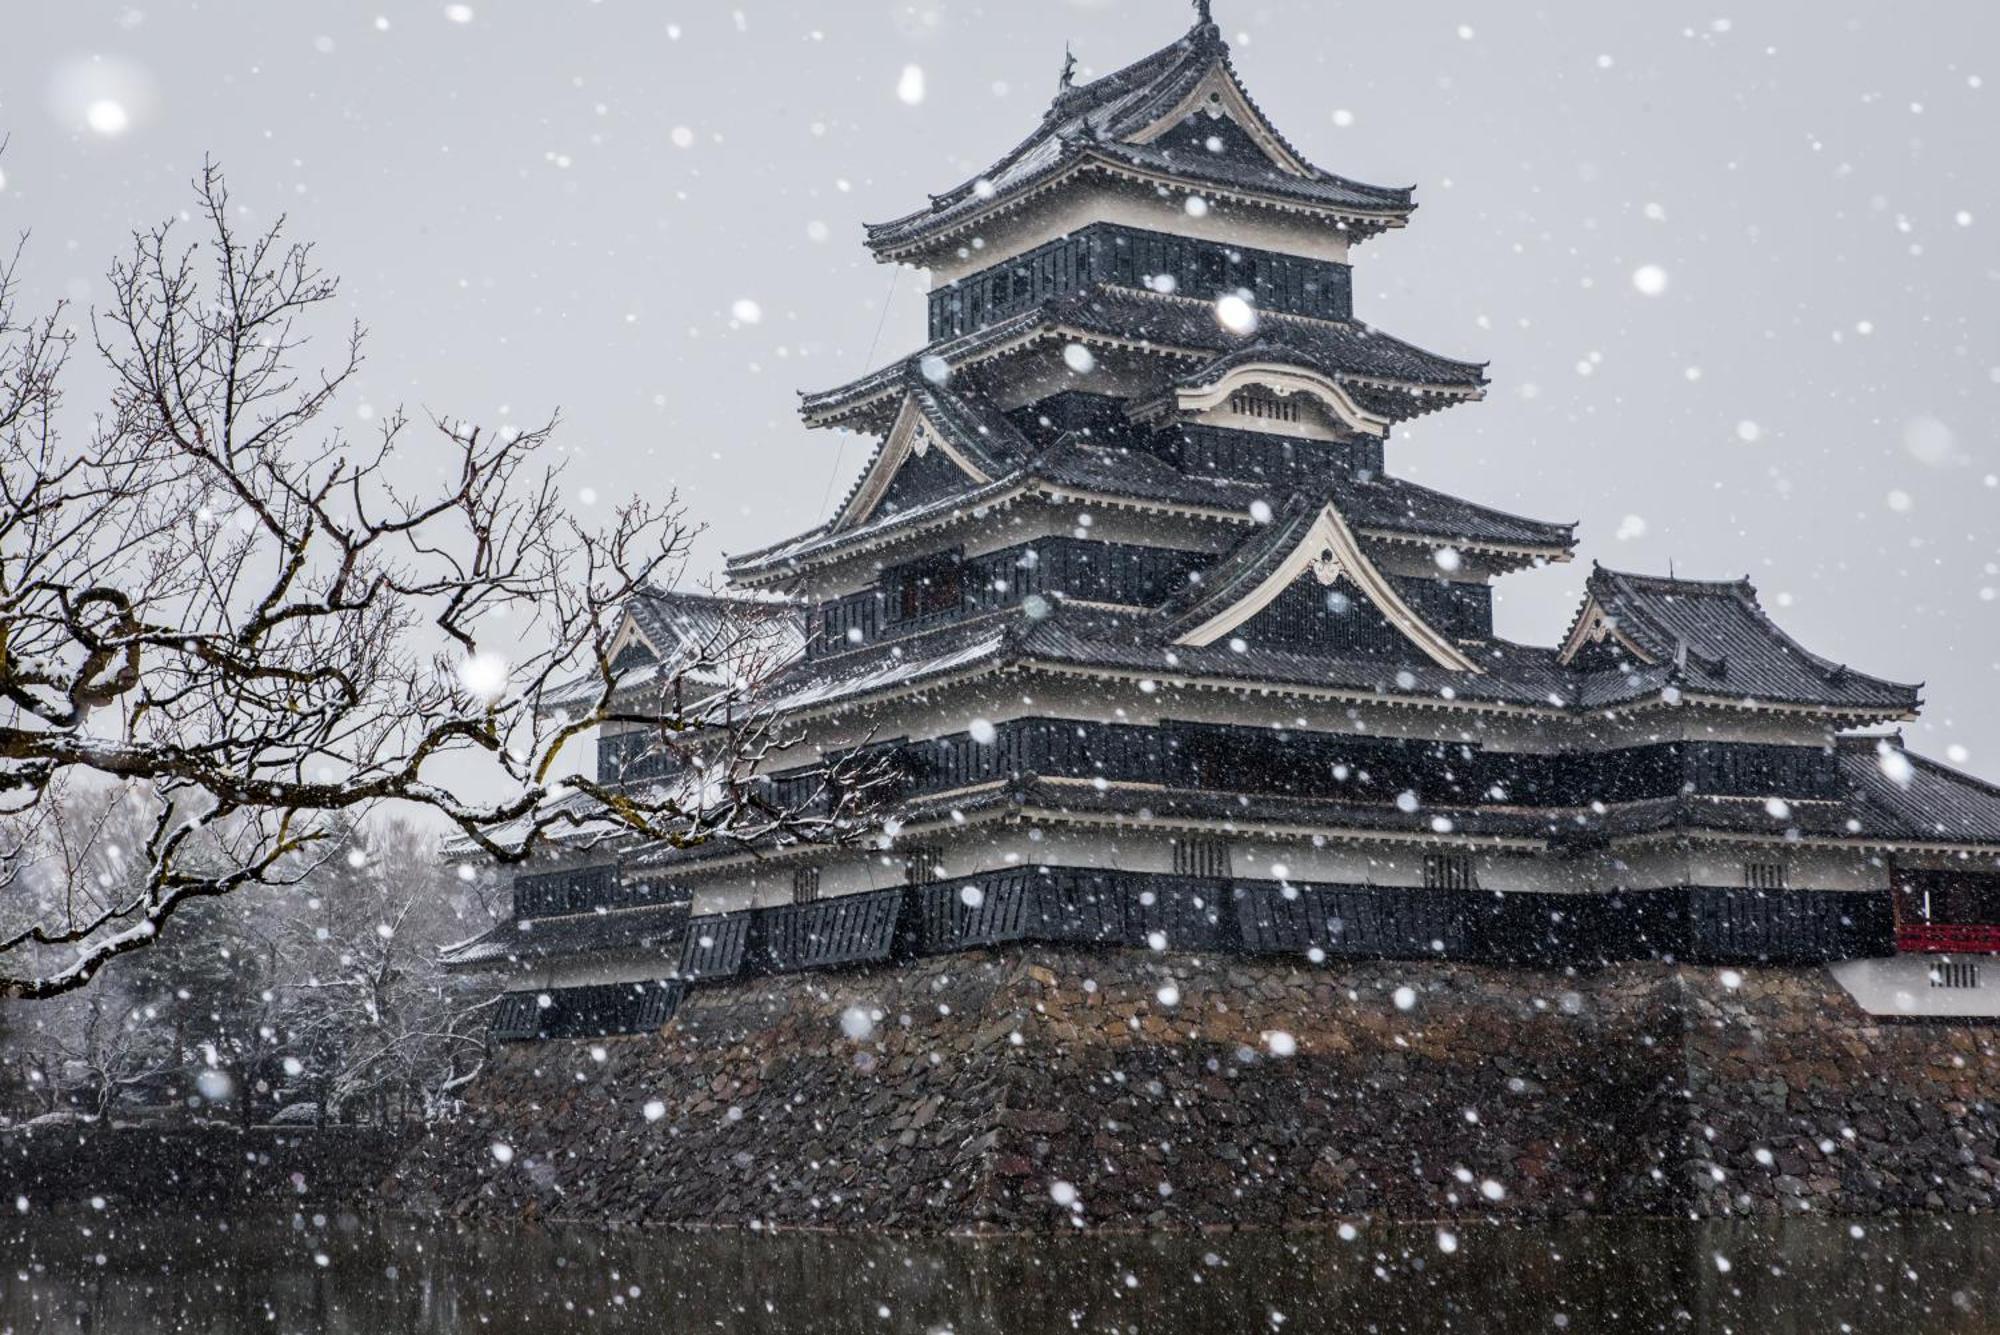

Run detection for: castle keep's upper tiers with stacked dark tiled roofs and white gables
[[730, 5, 1916, 723]]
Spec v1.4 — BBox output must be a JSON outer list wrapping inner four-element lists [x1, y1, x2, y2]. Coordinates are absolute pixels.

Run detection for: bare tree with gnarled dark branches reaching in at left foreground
[[0, 166, 858, 997]]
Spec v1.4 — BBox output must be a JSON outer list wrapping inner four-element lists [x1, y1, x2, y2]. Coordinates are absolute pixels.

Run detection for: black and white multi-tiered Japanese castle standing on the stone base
[[448, 4, 2000, 1039]]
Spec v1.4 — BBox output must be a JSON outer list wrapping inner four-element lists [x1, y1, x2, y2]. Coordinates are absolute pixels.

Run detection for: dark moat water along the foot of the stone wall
[[0, 1215, 2000, 1335]]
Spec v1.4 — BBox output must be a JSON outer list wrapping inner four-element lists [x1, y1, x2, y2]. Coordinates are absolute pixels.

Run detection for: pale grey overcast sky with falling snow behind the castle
[[0, 0, 2000, 775]]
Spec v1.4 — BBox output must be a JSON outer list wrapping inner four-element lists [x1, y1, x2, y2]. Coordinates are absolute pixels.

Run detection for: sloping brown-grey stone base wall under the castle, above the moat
[[404, 949, 2000, 1229]]
